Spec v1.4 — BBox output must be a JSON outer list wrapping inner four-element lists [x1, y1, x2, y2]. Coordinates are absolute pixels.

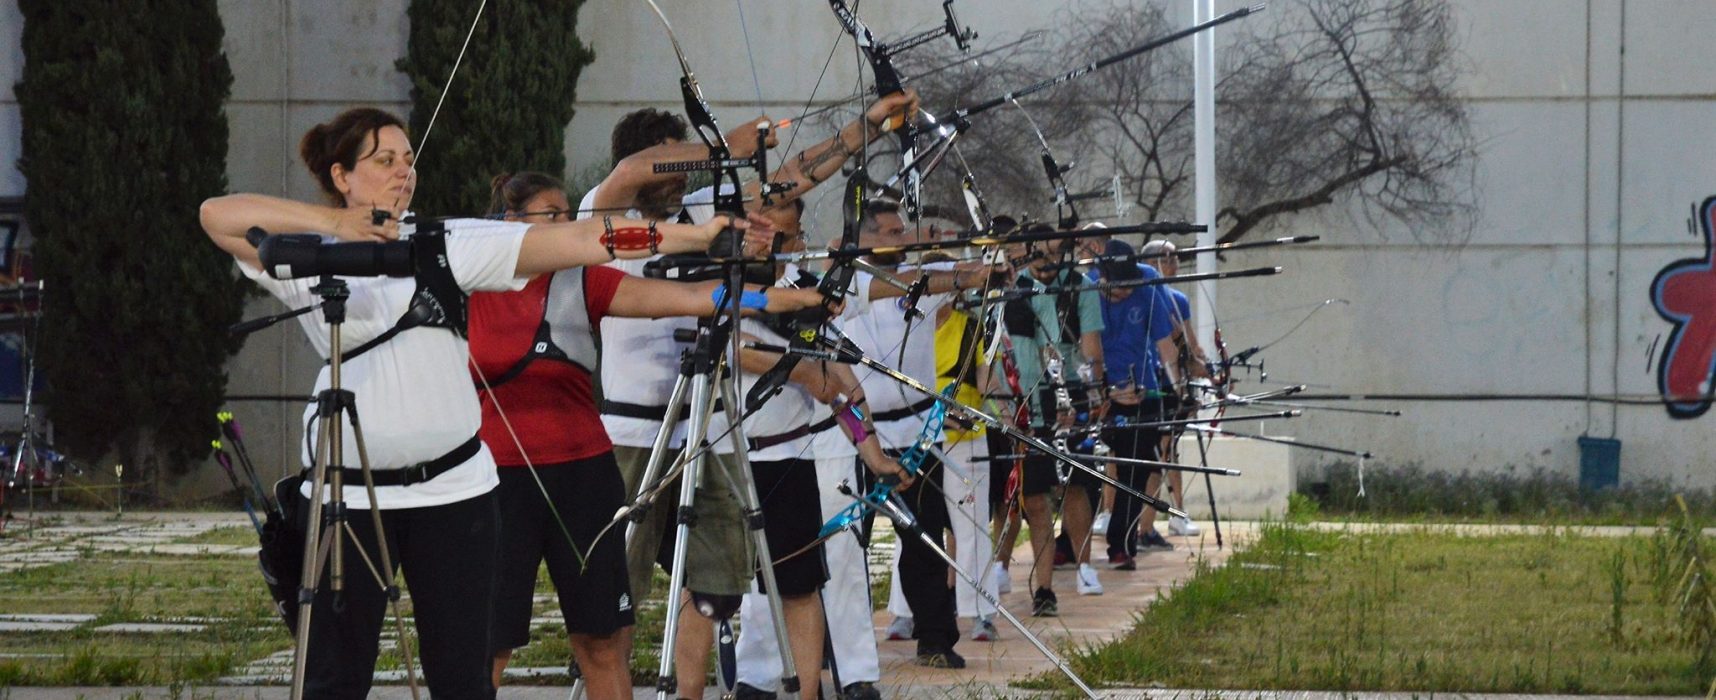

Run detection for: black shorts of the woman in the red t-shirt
[[494, 451, 635, 650]]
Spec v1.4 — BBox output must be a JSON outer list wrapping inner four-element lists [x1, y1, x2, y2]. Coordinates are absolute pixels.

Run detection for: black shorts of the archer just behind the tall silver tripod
[[752, 460, 829, 597]]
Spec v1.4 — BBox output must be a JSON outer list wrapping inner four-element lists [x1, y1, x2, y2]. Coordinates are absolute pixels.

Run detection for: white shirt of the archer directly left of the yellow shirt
[[841, 263, 952, 450]]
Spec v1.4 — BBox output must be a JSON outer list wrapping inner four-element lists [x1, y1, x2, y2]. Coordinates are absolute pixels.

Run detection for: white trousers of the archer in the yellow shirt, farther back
[[887, 438, 995, 618]]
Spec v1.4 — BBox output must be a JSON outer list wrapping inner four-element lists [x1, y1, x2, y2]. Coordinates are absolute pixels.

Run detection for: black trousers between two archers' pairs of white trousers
[[889, 451, 959, 650]]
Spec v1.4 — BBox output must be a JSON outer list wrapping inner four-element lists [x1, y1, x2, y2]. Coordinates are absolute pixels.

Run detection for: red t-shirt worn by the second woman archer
[[470, 266, 626, 467]]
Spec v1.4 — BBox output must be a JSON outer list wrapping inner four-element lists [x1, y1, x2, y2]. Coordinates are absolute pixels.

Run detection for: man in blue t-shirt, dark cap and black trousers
[[1100, 240, 1179, 570]]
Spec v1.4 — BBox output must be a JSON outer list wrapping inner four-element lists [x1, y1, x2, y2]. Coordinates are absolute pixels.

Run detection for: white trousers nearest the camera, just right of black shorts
[[738, 456, 882, 690]]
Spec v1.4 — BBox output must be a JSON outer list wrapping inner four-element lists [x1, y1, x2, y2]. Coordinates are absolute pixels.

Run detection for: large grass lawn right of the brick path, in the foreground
[[1033, 523, 1709, 695]]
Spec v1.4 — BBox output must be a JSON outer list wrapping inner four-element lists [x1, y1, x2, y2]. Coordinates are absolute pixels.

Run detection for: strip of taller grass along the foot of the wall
[[1289, 462, 1716, 525]]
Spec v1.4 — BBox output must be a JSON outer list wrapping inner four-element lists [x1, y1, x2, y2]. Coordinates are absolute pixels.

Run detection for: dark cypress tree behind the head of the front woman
[[396, 0, 595, 216]]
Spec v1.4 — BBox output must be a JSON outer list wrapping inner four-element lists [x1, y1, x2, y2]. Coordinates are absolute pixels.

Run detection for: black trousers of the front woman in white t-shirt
[[304, 491, 499, 700]]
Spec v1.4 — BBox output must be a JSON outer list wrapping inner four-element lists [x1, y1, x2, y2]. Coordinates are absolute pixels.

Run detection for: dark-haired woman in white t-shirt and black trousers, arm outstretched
[[201, 108, 767, 698]]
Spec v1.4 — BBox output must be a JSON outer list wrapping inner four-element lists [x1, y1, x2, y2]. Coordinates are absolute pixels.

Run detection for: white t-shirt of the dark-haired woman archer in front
[[239, 220, 530, 510]]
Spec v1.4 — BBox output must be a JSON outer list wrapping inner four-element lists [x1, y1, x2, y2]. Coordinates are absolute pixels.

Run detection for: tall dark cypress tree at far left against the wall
[[17, 0, 247, 484]]
